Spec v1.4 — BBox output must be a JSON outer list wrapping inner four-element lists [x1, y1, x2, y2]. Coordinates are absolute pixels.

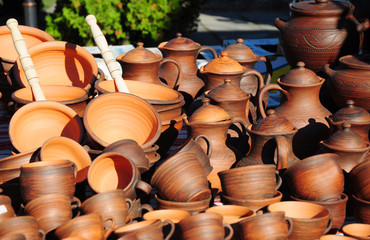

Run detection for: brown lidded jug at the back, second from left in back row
[[158, 33, 217, 101]]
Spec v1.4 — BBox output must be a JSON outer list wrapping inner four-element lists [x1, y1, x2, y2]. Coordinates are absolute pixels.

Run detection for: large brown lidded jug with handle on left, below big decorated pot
[[258, 62, 331, 159]]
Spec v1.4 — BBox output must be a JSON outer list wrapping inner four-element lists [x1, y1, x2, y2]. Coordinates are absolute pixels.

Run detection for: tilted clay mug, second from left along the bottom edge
[[54, 213, 115, 240]]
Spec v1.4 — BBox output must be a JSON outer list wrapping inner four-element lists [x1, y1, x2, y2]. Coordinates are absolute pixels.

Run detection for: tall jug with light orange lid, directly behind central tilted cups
[[184, 98, 236, 190]]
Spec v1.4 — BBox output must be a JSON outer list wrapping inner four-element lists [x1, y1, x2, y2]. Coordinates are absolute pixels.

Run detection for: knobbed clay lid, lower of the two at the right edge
[[324, 122, 367, 149]]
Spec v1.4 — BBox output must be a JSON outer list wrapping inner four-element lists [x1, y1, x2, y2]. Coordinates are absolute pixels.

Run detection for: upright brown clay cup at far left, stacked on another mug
[[19, 160, 76, 203]]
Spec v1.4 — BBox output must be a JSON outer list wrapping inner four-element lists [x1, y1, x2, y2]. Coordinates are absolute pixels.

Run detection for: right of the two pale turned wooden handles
[[85, 15, 130, 93]]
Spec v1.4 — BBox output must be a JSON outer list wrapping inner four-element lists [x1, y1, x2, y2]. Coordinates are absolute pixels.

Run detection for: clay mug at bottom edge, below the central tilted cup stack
[[179, 212, 234, 240]]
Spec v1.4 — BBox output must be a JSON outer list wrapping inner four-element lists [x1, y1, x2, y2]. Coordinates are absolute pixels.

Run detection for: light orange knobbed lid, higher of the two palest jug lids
[[203, 51, 246, 74]]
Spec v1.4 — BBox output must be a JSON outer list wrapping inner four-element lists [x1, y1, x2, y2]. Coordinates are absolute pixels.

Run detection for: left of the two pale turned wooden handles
[[6, 18, 46, 101]]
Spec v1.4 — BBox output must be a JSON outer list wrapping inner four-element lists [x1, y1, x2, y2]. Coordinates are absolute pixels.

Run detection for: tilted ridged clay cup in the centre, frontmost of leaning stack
[[150, 152, 211, 202]]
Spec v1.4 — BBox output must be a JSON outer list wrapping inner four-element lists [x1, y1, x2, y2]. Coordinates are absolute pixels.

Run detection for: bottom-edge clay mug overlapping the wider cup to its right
[[239, 212, 293, 240]]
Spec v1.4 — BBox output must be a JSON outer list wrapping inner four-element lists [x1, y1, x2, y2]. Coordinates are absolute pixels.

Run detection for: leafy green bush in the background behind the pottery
[[46, 0, 205, 46]]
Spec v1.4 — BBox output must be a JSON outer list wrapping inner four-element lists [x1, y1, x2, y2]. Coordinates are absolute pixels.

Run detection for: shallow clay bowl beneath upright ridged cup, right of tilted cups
[[222, 191, 283, 212]]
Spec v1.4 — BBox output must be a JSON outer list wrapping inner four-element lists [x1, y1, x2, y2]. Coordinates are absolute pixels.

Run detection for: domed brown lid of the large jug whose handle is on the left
[[280, 62, 321, 85]]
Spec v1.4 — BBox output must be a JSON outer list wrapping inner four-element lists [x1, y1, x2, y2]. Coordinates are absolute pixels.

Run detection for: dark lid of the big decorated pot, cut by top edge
[[290, 0, 351, 16]]
